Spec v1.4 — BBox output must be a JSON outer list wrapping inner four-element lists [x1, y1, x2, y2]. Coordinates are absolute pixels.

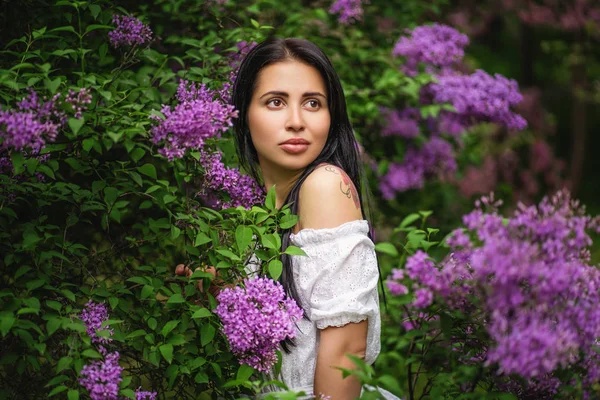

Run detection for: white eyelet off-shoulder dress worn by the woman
[[270, 220, 398, 399]]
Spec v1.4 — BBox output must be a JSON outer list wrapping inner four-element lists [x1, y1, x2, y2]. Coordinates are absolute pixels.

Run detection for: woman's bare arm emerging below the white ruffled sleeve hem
[[313, 320, 368, 400]]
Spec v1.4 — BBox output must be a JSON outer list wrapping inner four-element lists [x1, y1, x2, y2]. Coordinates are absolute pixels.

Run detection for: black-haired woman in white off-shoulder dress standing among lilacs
[[232, 38, 395, 400]]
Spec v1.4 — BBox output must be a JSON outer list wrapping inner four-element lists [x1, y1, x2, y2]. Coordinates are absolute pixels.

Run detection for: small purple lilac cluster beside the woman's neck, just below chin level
[[198, 152, 264, 208]]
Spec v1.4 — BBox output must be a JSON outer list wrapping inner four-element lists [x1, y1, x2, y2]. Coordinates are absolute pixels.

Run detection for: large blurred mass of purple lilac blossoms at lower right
[[388, 191, 600, 394]]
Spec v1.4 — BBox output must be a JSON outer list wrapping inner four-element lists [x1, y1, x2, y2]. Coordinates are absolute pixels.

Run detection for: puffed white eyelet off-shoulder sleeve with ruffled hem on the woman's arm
[[290, 220, 381, 363]]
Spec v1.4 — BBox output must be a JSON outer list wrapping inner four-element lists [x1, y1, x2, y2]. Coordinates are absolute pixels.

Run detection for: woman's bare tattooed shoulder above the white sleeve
[[298, 164, 362, 229]]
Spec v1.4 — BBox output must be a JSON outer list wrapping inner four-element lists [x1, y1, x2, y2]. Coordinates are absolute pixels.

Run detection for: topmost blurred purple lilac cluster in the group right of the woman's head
[[392, 23, 469, 76]]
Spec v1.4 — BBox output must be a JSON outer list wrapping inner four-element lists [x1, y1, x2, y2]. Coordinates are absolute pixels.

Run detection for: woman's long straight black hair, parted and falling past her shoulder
[[232, 38, 372, 351]]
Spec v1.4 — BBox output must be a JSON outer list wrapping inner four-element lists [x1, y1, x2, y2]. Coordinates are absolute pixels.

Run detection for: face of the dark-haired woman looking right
[[248, 61, 331, 174]]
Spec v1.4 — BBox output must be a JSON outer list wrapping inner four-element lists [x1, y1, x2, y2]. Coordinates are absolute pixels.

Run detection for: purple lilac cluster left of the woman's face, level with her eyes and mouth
[[152, 80, 238, 161]]
